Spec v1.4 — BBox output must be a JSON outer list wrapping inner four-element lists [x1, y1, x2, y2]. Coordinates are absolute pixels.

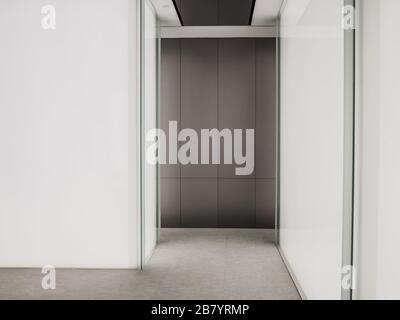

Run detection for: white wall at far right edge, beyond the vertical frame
[[357, 0, 400, 299]]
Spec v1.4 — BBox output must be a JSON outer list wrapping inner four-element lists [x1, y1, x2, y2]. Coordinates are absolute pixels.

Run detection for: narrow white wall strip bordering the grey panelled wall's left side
[[144, 0, 157, 262]]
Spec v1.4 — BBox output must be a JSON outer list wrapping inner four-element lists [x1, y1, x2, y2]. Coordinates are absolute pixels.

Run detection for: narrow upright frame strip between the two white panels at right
[[341, 0, 357, 300]]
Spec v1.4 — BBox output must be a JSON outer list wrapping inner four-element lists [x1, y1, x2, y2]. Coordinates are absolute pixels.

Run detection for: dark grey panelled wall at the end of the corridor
[[161, 39, 276, 228]]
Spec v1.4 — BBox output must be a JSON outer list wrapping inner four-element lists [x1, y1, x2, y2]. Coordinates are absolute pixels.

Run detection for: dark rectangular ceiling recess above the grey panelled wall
[[173, 0, 256, 26]]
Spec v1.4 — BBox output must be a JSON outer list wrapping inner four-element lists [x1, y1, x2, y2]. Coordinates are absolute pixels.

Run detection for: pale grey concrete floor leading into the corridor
[[0, 229, 300, 300]]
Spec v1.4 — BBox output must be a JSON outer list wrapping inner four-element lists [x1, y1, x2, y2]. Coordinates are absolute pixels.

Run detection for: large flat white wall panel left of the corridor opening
[[0, 0, 138, 268]]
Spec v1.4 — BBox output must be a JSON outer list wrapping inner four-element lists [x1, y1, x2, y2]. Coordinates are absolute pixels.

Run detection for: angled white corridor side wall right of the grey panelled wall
[[280, 0, 344, 299]]
